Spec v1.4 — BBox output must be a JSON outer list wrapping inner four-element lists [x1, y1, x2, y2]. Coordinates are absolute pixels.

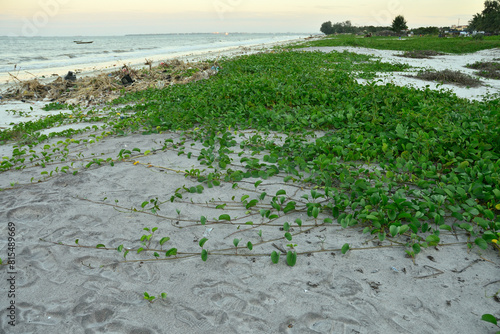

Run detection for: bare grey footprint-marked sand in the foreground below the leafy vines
[[0, 45, 500, 334]]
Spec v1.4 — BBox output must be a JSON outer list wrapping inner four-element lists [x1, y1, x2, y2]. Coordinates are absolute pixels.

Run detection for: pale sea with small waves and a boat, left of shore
[[0, 33, 309, 84]]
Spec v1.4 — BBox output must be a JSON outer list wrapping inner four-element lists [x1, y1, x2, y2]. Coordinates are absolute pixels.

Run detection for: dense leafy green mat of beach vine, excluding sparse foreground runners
[[0, 52, 500, 258]]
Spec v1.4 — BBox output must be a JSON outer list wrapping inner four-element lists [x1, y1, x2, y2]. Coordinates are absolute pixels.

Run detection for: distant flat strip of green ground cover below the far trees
[[293, 35, 500, 54]]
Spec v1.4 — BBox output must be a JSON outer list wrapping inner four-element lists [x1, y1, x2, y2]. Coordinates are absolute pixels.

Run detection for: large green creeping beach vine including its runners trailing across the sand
[[0, 38, 500, 284]]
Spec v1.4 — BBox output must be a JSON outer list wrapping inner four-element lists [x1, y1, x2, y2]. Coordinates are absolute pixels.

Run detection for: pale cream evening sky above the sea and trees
[[0, 0, 484, 36]]
